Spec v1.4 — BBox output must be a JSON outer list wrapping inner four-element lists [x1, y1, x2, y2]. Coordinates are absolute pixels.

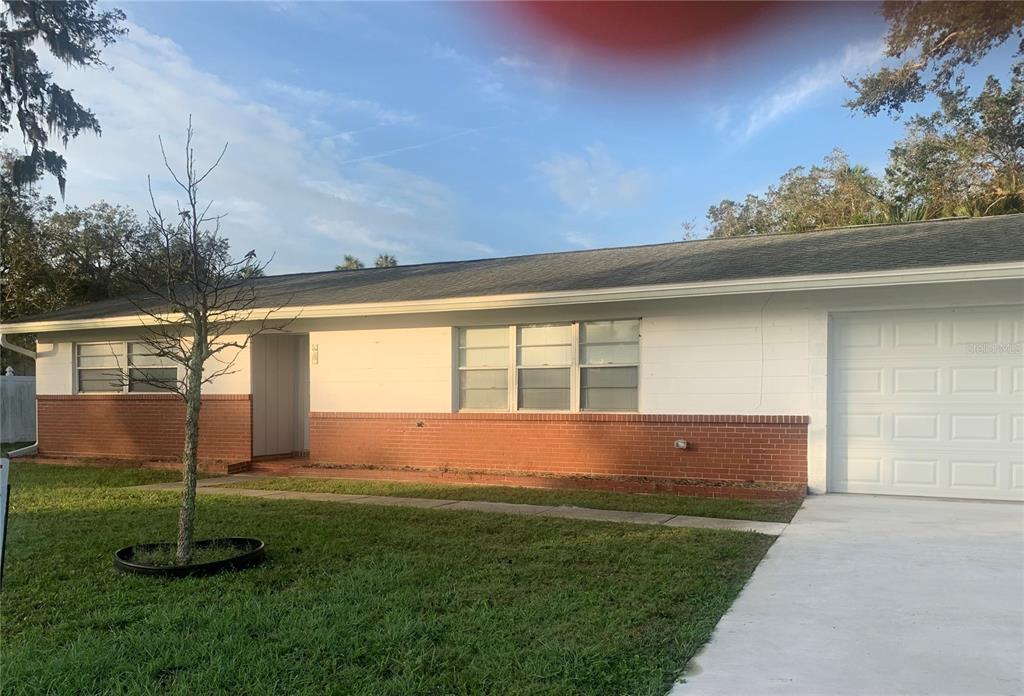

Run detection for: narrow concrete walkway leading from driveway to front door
[[135, 474, 787, 536]]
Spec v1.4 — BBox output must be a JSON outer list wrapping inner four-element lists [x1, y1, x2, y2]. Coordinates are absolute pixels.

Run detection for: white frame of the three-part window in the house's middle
[[452, 316, 643, 414]]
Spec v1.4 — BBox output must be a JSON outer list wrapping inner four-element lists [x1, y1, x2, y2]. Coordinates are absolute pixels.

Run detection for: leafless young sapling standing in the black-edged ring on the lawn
[[121, 118, 288, 565]]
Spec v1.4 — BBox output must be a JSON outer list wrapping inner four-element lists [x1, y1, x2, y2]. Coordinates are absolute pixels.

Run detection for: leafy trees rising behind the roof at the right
[[708, 1, 1024, 236]]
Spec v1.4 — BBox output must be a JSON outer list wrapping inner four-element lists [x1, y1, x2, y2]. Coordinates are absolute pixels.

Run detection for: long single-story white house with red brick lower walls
[[0, 215, 1024, 501]]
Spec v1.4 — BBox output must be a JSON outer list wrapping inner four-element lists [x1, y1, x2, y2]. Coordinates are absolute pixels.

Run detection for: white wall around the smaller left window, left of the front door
[[36, 331, 252, 395]]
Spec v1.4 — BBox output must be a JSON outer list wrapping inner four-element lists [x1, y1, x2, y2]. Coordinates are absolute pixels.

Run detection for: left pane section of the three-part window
[[459, 327, 509, 410]]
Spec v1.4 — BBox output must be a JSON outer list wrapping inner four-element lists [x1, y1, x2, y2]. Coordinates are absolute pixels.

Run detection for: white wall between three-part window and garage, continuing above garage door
[[640, 280, 1024, 492]]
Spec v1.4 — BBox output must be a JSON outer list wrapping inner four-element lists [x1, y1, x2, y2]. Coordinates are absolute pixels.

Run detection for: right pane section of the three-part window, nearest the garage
[[580, 319, 640, 410]]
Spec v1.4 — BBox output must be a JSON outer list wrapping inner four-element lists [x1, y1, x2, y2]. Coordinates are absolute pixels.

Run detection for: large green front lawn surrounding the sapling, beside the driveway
[[0, 462, 772, 695]]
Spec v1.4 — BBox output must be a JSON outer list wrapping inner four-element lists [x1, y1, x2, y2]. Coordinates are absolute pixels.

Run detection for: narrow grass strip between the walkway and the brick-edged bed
[[227, 478, 800, 522]]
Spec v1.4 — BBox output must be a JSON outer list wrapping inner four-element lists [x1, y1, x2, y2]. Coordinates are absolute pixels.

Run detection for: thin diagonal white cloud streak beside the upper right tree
[[737, 39, 885, 140]]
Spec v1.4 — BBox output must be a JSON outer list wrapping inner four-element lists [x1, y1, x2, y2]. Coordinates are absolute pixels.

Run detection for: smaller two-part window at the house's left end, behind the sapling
[[75, 342, 178, 394]]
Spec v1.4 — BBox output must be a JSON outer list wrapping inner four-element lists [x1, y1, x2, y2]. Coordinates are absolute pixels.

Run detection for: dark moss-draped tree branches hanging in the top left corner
[[0, 0, 126, 195]]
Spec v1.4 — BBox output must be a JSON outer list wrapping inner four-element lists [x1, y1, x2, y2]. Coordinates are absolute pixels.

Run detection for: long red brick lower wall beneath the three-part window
[[309, 412, 809, 487]]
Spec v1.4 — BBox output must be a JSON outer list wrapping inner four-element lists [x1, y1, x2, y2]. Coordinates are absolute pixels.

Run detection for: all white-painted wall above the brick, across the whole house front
[[28, 280, 1024, 492]]
